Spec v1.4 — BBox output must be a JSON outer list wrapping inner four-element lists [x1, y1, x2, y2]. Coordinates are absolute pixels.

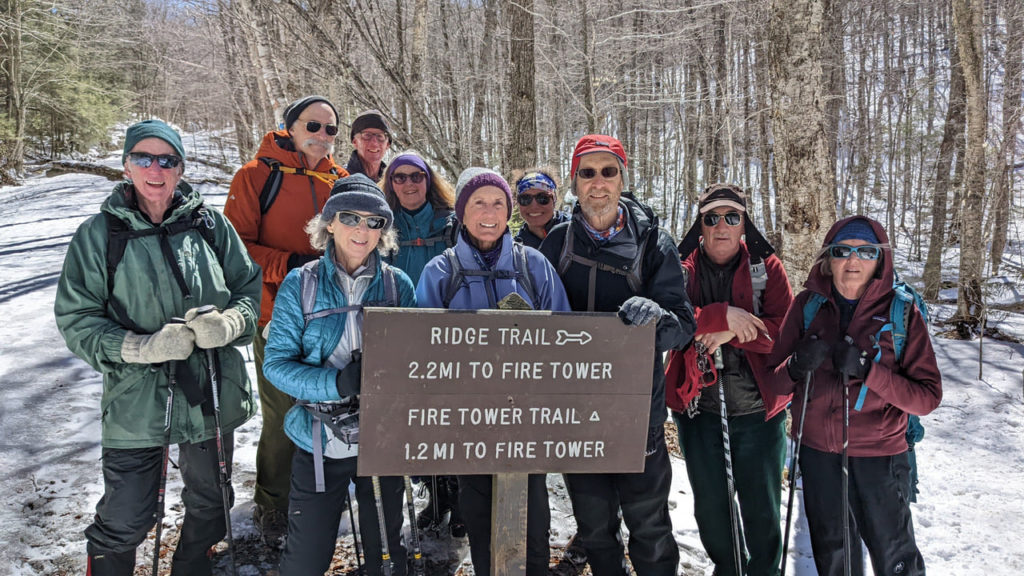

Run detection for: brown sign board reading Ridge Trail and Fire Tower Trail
[[358, 308, 654, 476]]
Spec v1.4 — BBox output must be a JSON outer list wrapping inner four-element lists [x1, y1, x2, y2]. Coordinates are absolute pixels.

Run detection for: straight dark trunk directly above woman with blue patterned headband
[[503, 0, 537, 169]]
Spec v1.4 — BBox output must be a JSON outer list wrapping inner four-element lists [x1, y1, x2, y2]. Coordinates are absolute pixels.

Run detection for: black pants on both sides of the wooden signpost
[[459, 474, 551, 576]]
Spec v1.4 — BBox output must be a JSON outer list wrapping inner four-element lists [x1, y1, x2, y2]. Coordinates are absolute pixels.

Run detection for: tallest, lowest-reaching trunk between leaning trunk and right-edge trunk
[[952, 0, 988, 332]]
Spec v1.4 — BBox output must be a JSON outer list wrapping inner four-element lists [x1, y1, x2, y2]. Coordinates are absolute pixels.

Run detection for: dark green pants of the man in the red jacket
[[672, 411, 785, 576]]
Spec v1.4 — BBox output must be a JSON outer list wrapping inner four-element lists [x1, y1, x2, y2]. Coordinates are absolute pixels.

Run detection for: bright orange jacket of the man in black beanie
[[224, 130, 348, 326]]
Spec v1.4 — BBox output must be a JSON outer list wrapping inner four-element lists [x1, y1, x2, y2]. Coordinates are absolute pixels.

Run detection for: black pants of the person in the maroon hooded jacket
[[800, 446, 925, 576]]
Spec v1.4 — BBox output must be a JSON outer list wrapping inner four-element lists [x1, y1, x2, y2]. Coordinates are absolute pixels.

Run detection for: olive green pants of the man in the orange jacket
[[253, 327, 295, 516]]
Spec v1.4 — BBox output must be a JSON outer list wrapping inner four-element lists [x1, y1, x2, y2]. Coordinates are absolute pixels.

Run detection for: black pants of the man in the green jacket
[[85, 434, 234, 576]]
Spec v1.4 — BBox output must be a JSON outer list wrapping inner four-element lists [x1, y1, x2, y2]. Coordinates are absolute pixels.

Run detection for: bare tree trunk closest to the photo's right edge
[[988, 5, 1024, 276]]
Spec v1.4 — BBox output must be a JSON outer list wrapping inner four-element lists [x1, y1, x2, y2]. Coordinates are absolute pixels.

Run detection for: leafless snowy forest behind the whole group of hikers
[[0, 0, 1024, 337]]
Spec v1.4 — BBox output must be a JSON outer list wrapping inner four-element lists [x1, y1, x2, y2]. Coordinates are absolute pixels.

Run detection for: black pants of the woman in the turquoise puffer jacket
[[281, 449, 406, 576]]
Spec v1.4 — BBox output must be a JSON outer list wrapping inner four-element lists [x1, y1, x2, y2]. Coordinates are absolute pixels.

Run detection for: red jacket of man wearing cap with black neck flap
[[665, 242, 793, 419]]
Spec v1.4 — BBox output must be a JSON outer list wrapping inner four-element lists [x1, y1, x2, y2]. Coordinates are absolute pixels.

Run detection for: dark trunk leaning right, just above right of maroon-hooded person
[[923, 19, 967, 300]]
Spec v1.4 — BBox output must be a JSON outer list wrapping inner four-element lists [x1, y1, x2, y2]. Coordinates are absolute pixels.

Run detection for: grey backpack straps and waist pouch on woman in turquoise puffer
[[295, 258, 400, 492]]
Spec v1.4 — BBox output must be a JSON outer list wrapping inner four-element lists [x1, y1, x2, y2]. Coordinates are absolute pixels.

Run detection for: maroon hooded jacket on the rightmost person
[[769, 216, 942, 456]]
